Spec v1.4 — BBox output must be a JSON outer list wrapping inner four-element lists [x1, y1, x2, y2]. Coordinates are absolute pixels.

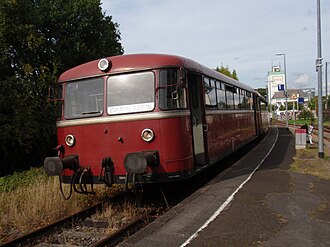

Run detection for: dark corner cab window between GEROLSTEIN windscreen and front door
[[159, 69, 187, 110]]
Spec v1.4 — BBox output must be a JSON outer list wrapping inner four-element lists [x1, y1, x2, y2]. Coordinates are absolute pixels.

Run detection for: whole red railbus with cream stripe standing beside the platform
[[44, 54, 268, 196]]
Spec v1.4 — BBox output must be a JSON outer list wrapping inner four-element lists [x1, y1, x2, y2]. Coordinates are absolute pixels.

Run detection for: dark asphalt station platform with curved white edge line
[[119, 127, 330, 247]]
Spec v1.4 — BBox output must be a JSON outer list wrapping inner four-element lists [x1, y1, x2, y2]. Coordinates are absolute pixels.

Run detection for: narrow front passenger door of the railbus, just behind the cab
[[188, 72, 208, 166]]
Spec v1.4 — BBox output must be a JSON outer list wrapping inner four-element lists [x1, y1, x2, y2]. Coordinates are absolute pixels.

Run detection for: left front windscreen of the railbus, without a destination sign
[[64, 78, 104, 118]]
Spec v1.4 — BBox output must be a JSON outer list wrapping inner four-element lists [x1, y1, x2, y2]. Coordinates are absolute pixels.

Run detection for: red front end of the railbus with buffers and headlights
[[44, 58, 194, 197]]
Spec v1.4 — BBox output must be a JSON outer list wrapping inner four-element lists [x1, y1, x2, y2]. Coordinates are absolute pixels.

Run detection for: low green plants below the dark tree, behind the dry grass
[[0, 168, 48, 193]]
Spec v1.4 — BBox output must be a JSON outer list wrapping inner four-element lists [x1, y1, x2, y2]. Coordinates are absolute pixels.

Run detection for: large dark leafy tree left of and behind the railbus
[[0, 0, 123, 176]]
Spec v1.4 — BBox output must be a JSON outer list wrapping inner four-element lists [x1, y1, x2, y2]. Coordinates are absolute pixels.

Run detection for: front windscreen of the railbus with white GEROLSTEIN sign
[[107, 72, 155, 115]]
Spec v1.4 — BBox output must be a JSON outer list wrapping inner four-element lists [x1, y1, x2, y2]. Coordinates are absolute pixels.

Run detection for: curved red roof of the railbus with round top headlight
[[58, 54, 255, 92]]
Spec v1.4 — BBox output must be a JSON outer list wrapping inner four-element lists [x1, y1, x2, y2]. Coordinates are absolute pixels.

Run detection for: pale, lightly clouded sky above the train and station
[[102, 0, 330, 91]]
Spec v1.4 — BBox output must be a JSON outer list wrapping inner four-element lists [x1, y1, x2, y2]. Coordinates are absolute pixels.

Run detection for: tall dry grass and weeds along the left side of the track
[[0, 169, 129, 243]]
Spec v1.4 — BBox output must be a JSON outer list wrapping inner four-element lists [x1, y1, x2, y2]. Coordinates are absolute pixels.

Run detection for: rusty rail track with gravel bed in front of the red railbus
[[0, 195, 161, 247]]
